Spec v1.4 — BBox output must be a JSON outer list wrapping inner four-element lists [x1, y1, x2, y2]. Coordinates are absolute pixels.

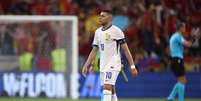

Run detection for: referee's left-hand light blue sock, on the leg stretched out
[[167, 83, 179, 100]]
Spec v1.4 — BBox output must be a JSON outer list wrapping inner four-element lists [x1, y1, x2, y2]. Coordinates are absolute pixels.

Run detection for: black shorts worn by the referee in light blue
[[171, 57, 186, 77]]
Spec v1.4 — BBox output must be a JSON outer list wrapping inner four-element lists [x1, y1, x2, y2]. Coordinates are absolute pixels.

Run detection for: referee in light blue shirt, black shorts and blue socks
[[167, 22, 192, 101]]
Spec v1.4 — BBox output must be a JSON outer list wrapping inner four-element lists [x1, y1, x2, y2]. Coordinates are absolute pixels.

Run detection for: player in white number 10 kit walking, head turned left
[[82, 10, 138, 101]]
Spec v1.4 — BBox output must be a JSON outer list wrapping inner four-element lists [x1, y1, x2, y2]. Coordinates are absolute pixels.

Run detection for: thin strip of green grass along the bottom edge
[[0, 98, 201, 101]]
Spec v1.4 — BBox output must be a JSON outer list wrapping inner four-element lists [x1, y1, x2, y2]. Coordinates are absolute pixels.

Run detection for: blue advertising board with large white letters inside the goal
[[0, 72, 67, 98]]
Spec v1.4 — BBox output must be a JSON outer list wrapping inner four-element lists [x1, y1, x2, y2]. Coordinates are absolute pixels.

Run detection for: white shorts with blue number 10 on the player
[[100, 71, 119, 86]]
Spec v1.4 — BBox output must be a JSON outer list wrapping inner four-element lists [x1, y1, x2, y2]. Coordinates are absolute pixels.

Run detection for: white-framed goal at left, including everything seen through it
[[0, 16, 79, 99]]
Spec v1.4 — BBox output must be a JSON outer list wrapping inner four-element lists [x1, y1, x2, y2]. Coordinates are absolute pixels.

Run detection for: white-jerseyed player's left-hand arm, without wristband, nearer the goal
[[82, 46, 98, 77]]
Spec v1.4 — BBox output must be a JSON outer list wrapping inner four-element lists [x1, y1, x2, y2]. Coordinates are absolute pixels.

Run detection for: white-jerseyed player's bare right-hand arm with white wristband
[[121, 42, 138, 76]]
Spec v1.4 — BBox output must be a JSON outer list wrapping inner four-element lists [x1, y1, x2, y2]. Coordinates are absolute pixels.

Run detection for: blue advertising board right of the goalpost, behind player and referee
[[80, 72, 201, 98]]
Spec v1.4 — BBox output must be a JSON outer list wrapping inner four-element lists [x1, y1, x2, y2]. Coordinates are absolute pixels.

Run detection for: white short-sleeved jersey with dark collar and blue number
[[93, 25, 125, 72]]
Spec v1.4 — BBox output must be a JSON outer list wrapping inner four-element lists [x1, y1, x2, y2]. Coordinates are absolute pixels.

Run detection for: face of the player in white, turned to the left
[[99, 12, 111, 25]]
